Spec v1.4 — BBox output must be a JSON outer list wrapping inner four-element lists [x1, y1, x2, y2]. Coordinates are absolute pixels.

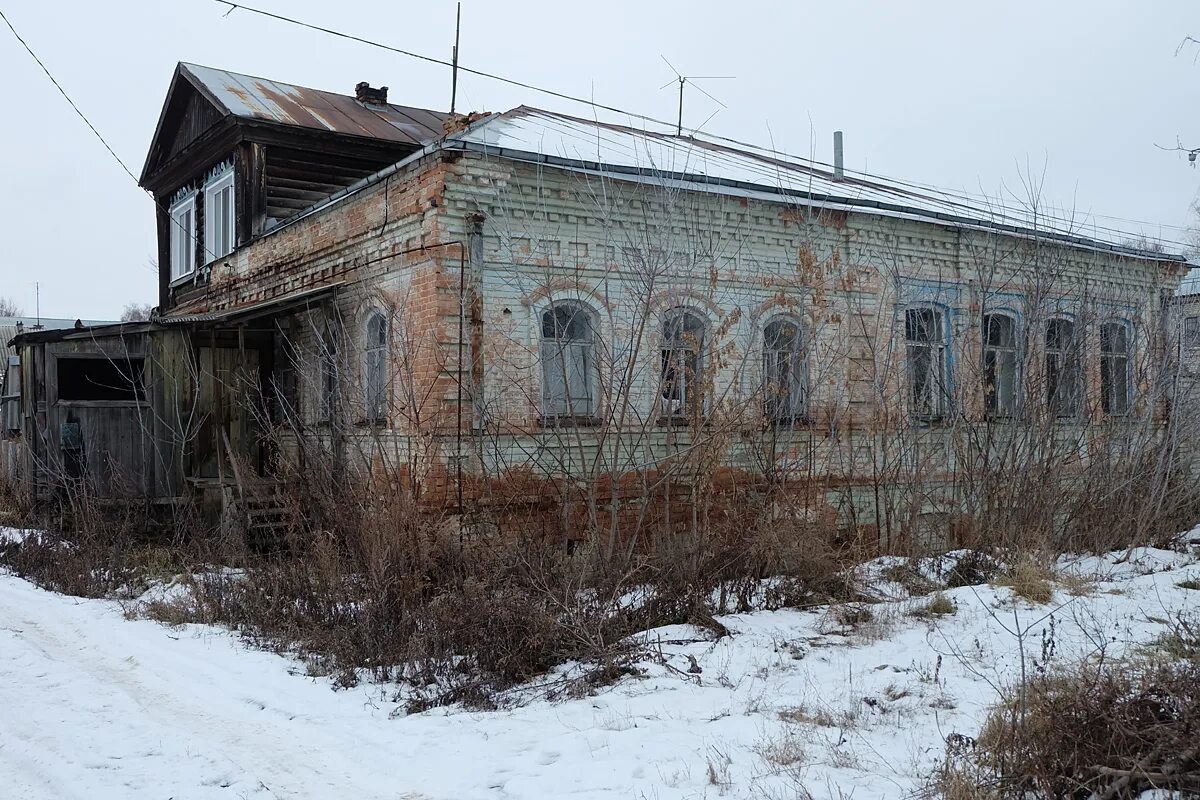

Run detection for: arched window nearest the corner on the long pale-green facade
[[541, 302, 598, 419]]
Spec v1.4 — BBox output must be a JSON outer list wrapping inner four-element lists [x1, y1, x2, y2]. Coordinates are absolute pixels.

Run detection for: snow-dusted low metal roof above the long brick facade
[[446, 107, 1182, 260]]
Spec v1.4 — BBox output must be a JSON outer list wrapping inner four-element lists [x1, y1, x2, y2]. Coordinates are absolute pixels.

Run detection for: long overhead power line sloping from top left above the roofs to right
[[214, 0, 1189, 247]]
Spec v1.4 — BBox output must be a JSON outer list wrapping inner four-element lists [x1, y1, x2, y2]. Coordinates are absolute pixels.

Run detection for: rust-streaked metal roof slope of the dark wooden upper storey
[[180, 64, 446, 145]]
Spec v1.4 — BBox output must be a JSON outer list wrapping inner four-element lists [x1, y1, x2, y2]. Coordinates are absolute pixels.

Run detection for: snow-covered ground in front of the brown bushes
[[0, 532, 1200, 800]]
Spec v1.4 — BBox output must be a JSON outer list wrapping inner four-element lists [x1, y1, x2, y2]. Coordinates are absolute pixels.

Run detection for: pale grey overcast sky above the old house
[[0, 0, 1200, 319]]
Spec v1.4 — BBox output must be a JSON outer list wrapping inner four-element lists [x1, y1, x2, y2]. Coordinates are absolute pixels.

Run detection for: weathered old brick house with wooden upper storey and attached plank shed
[[9, 65, 1186, 537]]
